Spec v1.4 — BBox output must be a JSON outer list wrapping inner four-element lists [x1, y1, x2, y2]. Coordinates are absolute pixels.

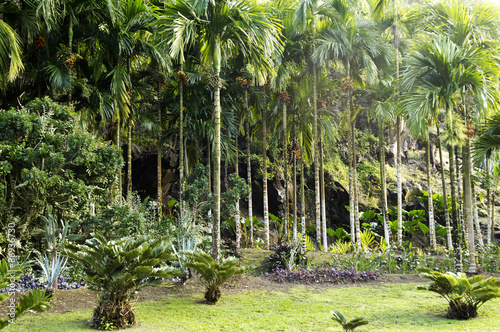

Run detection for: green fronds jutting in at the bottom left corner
[[0, 259, 53, 330]]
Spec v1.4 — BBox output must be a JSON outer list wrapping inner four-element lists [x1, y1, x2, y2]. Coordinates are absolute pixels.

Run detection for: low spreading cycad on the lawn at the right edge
[[417, 268, 500, 319]]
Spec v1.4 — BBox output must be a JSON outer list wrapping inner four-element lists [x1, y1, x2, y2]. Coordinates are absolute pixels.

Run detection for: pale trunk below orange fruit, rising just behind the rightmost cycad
[[462, 139, 476, 273]]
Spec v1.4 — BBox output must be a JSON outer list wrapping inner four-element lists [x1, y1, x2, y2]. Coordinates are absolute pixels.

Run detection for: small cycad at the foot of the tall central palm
[[184, 251, 248, 304]]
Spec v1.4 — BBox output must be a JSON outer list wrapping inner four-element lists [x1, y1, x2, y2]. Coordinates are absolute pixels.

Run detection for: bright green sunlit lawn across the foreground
[[6, 284, 500, 332]]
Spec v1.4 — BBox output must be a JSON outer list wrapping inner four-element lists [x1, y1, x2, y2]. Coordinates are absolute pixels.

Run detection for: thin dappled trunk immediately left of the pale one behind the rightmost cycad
[[448, 146, 463, 272]]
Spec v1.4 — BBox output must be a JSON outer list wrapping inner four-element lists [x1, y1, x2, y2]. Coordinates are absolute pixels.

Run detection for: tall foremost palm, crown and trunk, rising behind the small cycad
[[167, 0, 280, 261]]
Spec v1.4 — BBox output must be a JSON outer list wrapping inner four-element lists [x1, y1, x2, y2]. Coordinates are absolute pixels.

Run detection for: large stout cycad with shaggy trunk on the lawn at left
[[64, 233, 177, 328]]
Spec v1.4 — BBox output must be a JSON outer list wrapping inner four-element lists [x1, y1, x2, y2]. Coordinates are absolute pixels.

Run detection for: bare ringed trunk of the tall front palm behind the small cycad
[[212, 71, 221, 262]]
